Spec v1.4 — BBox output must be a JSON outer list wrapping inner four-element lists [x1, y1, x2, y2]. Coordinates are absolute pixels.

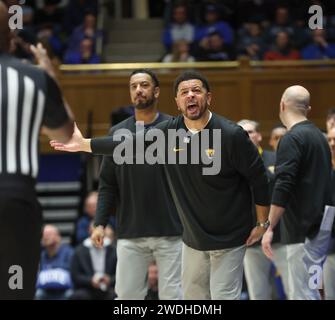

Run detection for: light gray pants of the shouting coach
[[182, 244, 245, 300]]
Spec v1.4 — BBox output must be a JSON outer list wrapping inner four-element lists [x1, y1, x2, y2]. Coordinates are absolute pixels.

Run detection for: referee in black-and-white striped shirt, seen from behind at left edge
[[0, 1, 73, 299]]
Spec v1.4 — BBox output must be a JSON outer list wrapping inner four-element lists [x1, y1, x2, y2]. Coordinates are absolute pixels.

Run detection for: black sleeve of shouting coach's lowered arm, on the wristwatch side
[[231, 128, 270, 206]]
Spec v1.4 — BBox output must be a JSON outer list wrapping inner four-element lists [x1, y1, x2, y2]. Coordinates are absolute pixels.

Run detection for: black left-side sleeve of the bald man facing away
[[271, 135, 301, 208]]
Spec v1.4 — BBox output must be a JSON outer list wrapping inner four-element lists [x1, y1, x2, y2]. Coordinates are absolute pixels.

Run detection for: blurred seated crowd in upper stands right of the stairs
[[163, 0, 335, 61]]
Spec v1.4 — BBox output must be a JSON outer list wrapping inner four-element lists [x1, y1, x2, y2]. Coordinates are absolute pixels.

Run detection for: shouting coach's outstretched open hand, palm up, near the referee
[[50, 123, 92, 152]]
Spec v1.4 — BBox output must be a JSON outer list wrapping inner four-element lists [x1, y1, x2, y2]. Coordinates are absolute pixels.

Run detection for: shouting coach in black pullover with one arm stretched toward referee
[[51, 72, 269, 299]]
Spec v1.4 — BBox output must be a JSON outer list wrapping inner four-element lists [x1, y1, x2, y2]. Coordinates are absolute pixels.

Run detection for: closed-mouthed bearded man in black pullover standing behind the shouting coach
[[92, 69, 182, 300]]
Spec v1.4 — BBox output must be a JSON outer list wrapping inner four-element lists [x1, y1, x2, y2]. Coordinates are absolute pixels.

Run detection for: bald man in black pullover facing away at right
[[262, 86, 332, 300]]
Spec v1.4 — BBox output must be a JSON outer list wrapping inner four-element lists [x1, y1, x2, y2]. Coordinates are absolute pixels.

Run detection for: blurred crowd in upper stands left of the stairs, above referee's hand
[[5, 0, 102, 64]]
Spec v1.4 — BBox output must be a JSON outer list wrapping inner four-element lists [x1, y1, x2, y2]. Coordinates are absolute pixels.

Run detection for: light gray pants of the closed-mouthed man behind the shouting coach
[[115, 237, 182, 300]]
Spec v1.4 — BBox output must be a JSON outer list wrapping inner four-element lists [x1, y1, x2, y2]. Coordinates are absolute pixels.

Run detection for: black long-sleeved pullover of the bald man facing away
[[272, 120, 332, 244]]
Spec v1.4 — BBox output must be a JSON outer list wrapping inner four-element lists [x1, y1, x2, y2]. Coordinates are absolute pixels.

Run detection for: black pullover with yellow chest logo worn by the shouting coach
[[91, 113, 269, 251]]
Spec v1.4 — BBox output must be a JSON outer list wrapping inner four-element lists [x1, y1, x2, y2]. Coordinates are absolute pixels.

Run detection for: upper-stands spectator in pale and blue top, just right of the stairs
[[163, 5, 194, 51]]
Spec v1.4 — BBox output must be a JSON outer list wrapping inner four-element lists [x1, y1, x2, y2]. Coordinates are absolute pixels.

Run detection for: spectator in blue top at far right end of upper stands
[[302, 29, 335, 60]]
